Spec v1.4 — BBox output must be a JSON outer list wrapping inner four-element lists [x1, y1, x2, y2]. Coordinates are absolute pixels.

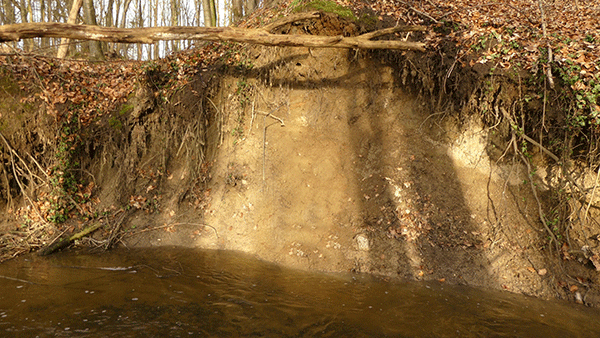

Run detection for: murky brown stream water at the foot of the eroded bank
[[0, 248, 600, 337]]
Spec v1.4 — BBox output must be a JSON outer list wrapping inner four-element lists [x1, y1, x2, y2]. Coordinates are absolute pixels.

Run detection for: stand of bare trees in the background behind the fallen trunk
[[0, 0, 273, 60]]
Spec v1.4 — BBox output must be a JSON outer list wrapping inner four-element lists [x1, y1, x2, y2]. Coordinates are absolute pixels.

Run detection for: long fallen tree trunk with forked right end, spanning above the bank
[[0, 12, 425, 51]]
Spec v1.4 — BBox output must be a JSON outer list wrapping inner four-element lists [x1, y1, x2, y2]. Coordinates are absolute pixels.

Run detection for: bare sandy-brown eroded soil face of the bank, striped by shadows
[[117, 48, 593, 299]]
